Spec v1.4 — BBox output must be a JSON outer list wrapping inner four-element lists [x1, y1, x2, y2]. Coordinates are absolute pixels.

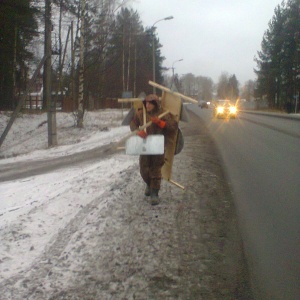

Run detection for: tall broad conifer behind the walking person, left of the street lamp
[[95, 8, 157, 97]]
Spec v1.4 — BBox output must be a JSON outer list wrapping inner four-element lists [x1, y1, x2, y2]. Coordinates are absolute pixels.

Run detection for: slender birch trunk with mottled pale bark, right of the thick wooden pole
[[77, 0, 85, 128]]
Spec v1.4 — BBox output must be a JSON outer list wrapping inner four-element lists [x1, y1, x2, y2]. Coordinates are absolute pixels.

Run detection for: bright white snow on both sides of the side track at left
[[0, 110, 137, 281]]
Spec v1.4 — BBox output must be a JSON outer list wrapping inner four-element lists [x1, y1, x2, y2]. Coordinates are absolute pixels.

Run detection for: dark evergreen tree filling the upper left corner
[[0, 0, 37, 109]]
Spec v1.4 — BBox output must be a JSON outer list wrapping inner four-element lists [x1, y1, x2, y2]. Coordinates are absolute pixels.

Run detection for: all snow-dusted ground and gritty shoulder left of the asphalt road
[[0, 110, 251, 300]]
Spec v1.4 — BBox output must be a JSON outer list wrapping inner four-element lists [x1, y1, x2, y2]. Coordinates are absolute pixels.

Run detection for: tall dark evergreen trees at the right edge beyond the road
[[255, 0, 300, 109]]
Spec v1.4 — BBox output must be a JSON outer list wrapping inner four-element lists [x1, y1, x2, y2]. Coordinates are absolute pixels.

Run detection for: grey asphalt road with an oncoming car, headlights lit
[[190, 106, 300, 300]]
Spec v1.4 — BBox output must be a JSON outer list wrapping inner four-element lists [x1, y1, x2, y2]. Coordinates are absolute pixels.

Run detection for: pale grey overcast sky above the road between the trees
[[132, 0, 281, 84]]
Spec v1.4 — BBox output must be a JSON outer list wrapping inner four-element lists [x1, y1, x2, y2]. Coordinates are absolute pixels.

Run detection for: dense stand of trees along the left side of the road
[[0, 0, 171, 113]]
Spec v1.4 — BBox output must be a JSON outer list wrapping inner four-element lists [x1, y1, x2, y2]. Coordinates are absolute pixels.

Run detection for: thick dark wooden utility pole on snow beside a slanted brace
[[43, 0, 57, 147]]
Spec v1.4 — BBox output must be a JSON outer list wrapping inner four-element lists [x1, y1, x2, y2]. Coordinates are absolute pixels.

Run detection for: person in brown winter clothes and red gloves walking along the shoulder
[[130, 94, 178, 205]]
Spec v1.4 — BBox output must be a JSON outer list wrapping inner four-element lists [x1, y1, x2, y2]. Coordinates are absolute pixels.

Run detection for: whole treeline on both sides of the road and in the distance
[[0, 0, 300, 112]]
